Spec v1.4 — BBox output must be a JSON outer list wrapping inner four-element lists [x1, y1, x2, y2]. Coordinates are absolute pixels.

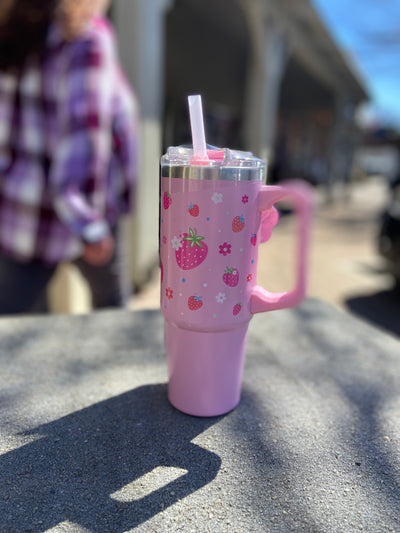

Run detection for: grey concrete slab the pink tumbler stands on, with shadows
[[0, 300, 400, 533]]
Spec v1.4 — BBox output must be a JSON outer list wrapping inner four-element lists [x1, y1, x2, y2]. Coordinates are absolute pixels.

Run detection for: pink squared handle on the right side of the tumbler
[[250, 181, 312, 313]]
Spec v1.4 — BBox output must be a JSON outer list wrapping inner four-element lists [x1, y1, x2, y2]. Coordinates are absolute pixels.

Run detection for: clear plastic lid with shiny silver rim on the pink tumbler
[[161, 145, 265, 182]]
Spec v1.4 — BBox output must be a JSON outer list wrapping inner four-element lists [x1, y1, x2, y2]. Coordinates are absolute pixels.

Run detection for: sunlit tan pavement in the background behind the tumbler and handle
[[130, 178, 392, 309]]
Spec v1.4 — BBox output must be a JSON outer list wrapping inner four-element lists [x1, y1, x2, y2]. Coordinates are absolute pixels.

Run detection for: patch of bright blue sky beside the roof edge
[[312, 0, 400, 128]]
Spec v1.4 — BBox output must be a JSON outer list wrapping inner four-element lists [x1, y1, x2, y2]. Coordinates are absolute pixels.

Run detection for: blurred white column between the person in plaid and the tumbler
[[113, 0, 171, 284]]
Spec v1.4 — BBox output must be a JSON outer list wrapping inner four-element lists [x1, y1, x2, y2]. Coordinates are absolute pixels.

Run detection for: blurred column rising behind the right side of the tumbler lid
[[242, 1, 288, 172]]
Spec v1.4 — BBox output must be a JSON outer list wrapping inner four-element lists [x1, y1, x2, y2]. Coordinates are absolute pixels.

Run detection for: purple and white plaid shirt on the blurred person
[[0, 18, 137, 264]]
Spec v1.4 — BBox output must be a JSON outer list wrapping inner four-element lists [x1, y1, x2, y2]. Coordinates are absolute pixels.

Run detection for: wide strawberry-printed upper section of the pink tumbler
[[160, 178, 261, 332]]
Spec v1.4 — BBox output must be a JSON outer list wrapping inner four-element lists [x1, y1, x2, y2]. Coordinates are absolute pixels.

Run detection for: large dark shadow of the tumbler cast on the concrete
[[0, 385, 221, 533]]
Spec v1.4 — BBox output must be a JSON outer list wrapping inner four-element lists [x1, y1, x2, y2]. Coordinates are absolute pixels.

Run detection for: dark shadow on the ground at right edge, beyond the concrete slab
[[345, 289, 400, 337]]
